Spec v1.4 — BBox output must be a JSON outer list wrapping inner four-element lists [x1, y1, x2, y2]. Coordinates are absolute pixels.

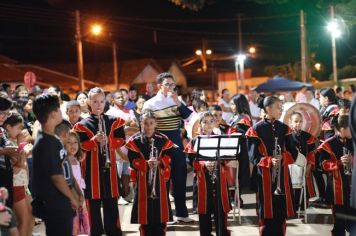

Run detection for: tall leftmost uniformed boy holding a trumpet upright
[[73, 87, 127, 236]]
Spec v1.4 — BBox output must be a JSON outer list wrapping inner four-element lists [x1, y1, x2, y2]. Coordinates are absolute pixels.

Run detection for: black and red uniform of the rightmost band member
[[318, 135, 356, 235]]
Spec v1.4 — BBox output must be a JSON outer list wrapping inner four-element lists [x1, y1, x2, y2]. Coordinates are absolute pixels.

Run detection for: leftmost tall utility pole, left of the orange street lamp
[[75, 10, 85, 91]]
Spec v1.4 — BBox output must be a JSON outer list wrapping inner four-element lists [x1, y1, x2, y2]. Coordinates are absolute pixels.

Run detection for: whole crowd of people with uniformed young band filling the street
[[0, 73, 356, 236]]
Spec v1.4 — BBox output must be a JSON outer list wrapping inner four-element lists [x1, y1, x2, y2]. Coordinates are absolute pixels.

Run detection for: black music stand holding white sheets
[[194, 134, 245, 236]]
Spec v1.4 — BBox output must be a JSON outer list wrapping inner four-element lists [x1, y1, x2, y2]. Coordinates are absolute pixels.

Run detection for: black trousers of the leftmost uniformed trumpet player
[[88, 198, 122, 236]]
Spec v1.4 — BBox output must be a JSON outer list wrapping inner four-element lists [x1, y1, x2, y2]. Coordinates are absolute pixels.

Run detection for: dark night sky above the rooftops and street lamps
[[0, 0, 356, 78]]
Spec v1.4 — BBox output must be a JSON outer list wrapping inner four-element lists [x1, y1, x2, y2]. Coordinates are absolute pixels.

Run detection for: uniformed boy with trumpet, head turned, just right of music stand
[[246, 96, 297, 236]]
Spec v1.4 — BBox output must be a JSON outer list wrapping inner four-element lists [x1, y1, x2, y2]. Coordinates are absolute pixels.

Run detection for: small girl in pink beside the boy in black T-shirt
[[65, 131, 90, 235]]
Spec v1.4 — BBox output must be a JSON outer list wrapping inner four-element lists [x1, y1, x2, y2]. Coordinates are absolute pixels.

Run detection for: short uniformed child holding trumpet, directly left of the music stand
[[126, 110, 175, 236]]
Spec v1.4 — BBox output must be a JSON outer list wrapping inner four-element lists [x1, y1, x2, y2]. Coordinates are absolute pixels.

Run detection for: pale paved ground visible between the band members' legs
[[35, 171, 340, 236]]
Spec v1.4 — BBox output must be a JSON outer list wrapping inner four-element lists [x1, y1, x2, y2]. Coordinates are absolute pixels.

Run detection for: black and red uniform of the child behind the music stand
[[184, 136, 231, 236]]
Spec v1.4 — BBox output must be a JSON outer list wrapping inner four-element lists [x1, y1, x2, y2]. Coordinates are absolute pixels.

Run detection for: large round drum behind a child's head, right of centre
[[280, 103, 322, 137]]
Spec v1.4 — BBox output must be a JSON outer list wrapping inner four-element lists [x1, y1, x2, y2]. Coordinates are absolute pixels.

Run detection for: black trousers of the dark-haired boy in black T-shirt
[[42, 205, 74, 236]]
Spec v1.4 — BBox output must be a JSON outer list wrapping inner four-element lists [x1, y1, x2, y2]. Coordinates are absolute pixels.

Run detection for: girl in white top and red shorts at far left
[[4, 113, 34, 236]]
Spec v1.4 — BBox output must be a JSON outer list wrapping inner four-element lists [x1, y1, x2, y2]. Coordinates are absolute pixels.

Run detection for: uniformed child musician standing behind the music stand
[[184, 111, 231, 236]]
